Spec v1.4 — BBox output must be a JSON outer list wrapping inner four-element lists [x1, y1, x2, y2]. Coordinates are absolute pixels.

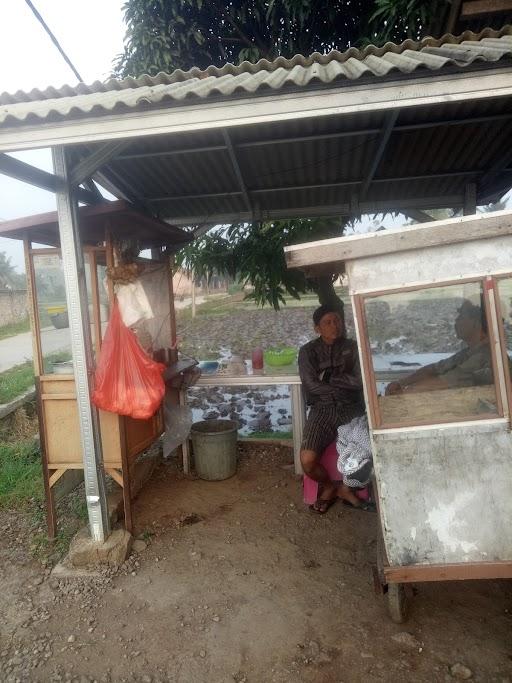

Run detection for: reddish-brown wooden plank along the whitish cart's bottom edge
[[384, 561, 512, 583]]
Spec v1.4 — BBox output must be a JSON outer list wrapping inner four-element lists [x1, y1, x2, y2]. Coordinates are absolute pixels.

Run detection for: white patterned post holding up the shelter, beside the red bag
[[52, 147, 110, 543]]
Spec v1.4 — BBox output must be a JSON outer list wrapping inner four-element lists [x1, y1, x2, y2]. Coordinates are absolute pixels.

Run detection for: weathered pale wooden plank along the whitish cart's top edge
[[285, 211, 512, 268]]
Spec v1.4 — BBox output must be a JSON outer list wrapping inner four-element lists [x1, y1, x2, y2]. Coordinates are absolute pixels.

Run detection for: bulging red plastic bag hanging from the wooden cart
[[92, 301, 165, 420]]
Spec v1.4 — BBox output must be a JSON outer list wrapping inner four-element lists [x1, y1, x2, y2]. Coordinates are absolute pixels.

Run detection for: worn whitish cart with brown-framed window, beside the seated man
[[286, 211, 512, 622]]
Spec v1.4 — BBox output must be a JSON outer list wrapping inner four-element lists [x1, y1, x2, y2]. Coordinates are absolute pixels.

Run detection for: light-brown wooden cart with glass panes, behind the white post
[[0, 201, 190, 537]]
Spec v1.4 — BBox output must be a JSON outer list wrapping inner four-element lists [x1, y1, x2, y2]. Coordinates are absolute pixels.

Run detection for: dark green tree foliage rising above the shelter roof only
[[115, 0, 450, 76]]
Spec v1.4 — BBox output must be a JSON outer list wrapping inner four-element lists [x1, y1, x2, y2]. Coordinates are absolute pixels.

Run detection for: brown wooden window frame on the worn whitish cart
[[353, 275, 512, 430]]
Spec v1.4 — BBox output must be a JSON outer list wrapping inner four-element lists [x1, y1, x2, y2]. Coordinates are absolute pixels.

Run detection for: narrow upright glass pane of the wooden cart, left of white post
[[33, 252, 73, 374]]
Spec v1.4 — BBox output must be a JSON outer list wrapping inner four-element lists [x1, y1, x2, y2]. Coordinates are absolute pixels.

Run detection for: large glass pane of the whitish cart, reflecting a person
[[364, 282, 498, 426]]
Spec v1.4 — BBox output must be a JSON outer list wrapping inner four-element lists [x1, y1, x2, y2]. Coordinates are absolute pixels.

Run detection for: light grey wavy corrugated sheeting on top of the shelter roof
[[0, 26, 512, 125]]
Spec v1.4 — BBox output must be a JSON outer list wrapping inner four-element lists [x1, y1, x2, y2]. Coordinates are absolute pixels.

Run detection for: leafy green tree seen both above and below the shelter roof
[[114, 0, 450, 308]]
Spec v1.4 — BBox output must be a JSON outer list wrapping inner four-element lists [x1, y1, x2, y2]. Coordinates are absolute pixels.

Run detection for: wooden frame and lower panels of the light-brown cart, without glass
[[7, 202, 188, 538]]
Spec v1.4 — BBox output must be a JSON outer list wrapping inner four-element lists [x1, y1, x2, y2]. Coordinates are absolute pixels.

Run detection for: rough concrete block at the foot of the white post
[[67, 528, 133, 568]]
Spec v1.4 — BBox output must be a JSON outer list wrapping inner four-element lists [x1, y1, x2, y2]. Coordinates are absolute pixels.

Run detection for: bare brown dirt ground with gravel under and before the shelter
[[0, 445, 512, 683]]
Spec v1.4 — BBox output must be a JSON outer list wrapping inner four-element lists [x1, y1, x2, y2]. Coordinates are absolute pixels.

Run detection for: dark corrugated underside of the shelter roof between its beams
[[93, 93, 512, 225]]
